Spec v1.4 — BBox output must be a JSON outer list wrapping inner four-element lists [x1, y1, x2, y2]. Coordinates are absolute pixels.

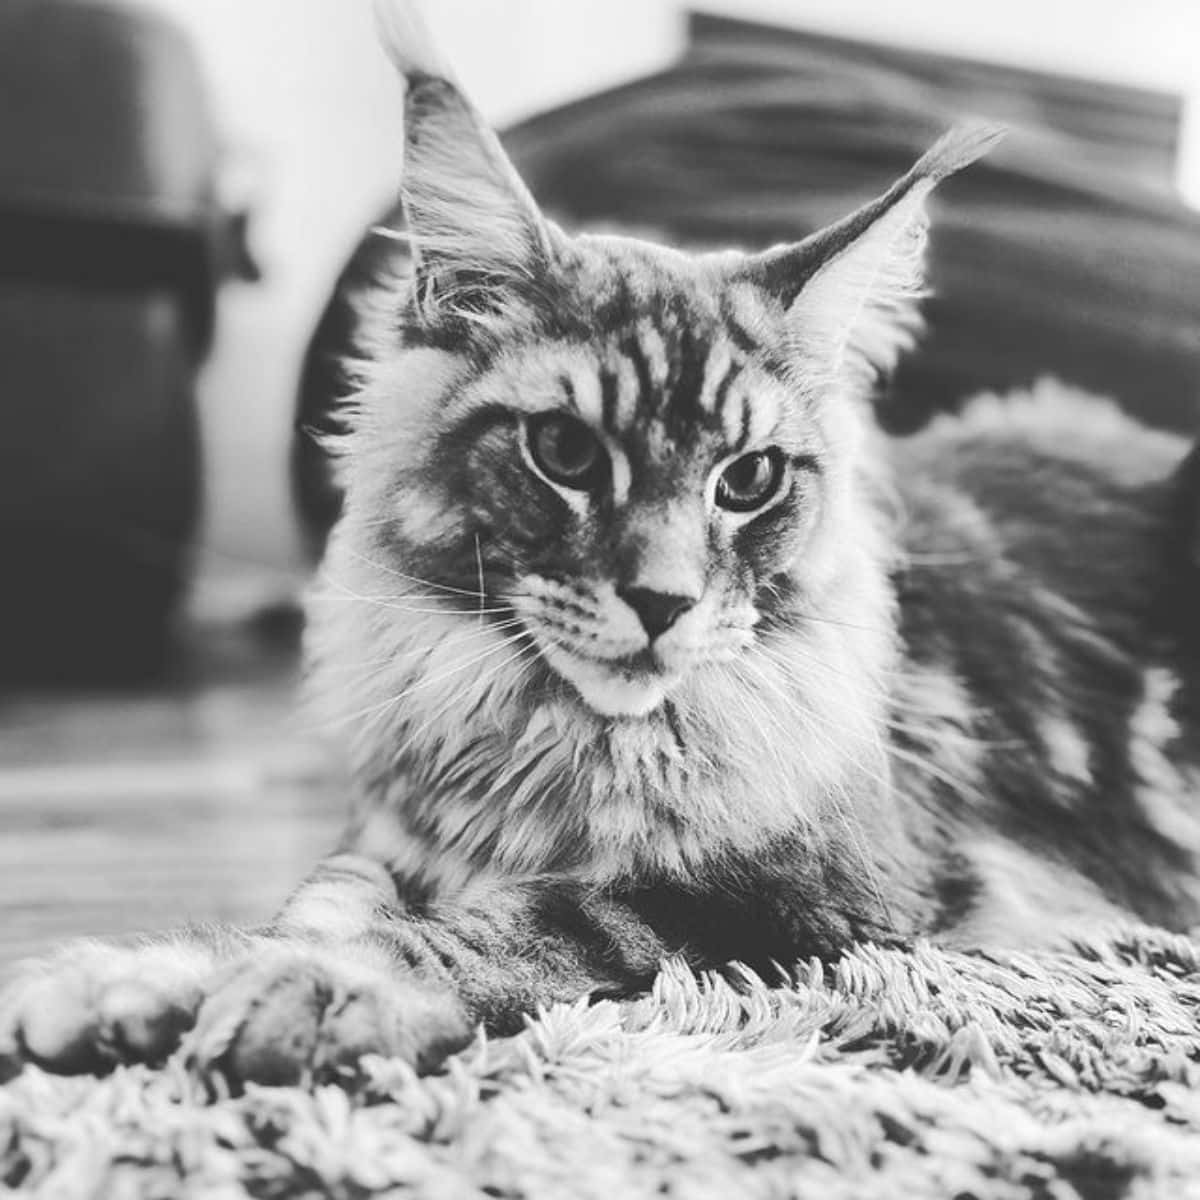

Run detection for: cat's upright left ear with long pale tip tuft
[[374, 0, 551, 325]]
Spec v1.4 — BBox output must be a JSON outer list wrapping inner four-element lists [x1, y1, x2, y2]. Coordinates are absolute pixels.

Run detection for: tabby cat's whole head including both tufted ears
[[336, 18, 982, 718]]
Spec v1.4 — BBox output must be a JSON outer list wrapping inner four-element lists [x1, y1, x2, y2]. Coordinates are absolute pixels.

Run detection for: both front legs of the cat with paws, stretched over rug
[[0, 854, 665, 1085]]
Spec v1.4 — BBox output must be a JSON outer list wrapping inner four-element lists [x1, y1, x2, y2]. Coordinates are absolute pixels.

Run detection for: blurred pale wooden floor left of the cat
[[0, 630, 344, 967]]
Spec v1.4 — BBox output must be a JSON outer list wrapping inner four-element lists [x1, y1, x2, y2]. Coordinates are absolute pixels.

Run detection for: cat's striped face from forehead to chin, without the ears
[[379, 239, 850, 716]]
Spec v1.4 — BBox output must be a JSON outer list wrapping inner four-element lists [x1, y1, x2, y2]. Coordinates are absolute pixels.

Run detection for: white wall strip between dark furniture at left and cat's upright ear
[[130, 0, 401, 592]]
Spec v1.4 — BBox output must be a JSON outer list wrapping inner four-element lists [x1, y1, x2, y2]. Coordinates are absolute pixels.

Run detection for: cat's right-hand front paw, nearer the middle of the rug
[[186, 942, 473, 1087]]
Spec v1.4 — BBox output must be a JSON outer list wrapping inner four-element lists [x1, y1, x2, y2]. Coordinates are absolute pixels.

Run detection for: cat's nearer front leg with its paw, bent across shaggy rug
[[186, 854, 664, 1084]]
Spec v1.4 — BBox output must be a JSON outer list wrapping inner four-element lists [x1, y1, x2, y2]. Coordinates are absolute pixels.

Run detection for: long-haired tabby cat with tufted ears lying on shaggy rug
[[0, 0, 1200, 1086]]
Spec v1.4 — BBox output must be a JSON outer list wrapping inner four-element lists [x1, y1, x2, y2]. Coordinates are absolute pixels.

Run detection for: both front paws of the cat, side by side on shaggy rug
[[0, 936, 472, 1086]]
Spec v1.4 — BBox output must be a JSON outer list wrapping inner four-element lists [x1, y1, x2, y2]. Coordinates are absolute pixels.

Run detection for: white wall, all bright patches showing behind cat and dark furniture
[[124, 0, 1200, 600]]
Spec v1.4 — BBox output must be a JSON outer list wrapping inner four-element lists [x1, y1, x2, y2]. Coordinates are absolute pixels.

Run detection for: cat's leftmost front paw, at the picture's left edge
[[0, 938, 214, 1080]]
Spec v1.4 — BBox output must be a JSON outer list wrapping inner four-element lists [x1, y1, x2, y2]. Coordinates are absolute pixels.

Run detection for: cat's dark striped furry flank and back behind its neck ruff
[[893, 382, 1200, 944]]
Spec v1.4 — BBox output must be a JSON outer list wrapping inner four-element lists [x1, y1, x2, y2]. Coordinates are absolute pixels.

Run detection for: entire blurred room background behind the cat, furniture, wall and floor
[[0, 0, 1200, 961]]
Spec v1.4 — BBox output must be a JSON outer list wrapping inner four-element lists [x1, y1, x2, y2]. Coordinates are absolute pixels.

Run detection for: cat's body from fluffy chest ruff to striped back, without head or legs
[[314, 382, 1200, 966]]
